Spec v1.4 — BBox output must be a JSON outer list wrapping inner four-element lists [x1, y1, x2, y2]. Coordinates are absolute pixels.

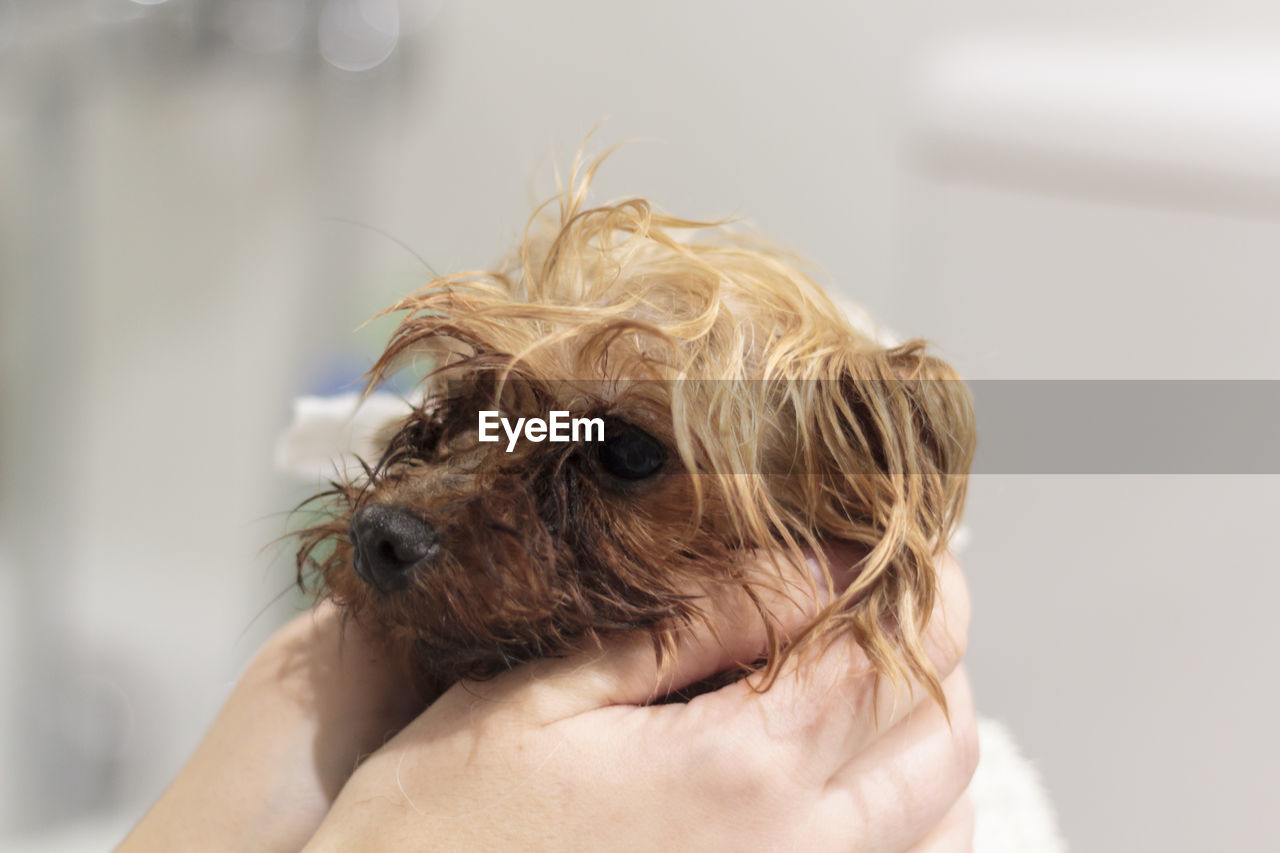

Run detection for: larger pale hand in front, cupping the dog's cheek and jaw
[[306, 556, 977, 853]]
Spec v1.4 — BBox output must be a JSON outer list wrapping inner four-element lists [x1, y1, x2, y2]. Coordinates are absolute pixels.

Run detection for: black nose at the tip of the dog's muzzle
[[351, 503, 439, 592]]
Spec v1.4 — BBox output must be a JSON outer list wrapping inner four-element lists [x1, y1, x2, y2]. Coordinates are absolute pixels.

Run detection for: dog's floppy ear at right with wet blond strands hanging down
[[796, 341, 975, 706]]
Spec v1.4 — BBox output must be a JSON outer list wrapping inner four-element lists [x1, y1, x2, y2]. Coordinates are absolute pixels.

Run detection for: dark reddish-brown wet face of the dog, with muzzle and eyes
[[305, 374, 727, 685]]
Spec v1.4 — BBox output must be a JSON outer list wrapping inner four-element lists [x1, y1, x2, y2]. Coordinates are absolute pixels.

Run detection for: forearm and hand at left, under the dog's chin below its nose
[[118, 603, 421, 853]]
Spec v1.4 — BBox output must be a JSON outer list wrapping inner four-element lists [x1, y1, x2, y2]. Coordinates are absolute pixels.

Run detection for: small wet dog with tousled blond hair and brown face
[[297, 151, 975, 703]]
